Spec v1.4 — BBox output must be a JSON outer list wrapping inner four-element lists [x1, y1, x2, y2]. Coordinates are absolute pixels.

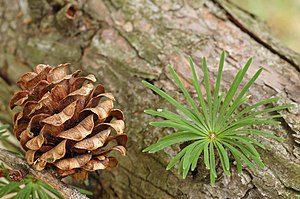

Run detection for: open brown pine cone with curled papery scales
[[10, 64, 127, 176]]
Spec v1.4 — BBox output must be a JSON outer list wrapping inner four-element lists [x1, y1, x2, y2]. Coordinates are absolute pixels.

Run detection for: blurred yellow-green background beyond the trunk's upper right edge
[[231, 0, 300, 52]]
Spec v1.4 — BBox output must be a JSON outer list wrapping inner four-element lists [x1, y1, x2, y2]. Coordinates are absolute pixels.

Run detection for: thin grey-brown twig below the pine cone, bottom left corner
[[0, 148, 88, 199]]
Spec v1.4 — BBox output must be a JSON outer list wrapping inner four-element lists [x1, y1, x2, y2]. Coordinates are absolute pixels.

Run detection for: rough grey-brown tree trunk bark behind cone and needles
[[0, 0, 300, 199]]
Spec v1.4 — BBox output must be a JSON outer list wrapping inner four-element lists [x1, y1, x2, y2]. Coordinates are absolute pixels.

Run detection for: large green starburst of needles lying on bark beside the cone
[[143, 51, 292, 186]]
